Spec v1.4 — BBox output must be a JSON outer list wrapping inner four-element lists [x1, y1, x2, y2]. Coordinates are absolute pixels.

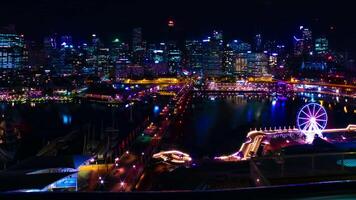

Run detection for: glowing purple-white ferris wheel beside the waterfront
[[297, 103, 328, 143]]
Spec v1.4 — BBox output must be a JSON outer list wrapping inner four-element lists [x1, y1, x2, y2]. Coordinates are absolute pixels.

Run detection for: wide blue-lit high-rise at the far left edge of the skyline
[[0, 33, 26, 69]]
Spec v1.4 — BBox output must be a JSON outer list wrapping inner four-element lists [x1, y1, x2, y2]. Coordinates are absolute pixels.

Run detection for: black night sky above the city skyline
[[0, 0, 356, 51]]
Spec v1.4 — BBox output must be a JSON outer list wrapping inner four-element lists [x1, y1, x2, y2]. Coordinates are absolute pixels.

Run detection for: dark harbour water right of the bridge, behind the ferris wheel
[[178, 94, 356, 158]]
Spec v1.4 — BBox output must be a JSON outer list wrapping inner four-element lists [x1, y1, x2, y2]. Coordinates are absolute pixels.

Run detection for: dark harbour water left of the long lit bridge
[[0, 98, 166, 160]]
